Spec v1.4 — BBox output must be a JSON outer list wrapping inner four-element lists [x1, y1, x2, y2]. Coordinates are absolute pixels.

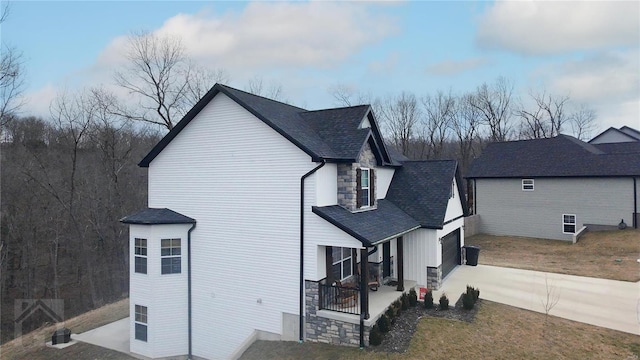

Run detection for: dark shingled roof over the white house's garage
[[386, 160, 467, 229]]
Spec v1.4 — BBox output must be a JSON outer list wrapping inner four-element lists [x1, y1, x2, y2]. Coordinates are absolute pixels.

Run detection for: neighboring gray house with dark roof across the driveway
[[467, 135, 640, 240]]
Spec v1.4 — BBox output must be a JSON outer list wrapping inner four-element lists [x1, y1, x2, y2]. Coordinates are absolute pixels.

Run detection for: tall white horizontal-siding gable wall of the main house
[[149, 93, 317, 359]]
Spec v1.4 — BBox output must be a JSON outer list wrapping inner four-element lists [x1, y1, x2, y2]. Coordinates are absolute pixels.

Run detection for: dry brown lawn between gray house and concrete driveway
[[465, 229, 640, 282]]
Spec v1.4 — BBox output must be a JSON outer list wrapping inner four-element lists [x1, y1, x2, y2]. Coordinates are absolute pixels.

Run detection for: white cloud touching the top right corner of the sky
[[476, 1, 640, 55]]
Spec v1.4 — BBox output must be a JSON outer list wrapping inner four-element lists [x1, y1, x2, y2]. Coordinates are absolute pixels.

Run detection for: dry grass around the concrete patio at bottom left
[[0, 299, 132, 360]]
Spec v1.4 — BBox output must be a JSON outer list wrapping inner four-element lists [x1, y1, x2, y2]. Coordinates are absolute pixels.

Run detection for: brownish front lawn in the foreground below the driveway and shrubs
[[241, 300, 640, 360]]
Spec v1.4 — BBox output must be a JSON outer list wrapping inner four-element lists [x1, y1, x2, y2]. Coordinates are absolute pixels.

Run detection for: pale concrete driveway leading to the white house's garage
[[433, 265, 640, 335]]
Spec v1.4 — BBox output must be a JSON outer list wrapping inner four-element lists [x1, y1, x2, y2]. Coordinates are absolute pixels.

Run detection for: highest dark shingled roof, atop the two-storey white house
[[139, 84, 397, 167]]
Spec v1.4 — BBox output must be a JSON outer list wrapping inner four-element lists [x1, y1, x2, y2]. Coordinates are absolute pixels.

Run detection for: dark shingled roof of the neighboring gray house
[[467, 135, 640, 178]]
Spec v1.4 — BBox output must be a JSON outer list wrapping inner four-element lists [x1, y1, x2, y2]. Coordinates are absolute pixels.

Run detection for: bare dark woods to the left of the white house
[[0, 108, 160, 342]]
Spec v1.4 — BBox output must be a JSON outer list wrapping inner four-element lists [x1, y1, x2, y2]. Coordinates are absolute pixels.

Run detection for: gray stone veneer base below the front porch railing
[[304, 280, 371, 346]]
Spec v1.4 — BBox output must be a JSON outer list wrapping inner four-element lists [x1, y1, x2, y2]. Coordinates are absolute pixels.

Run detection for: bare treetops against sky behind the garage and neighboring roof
[[329, 77, 596, 174]]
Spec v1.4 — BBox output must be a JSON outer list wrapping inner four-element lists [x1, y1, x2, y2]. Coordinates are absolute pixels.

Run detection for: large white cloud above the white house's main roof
[[99, 2, 396, 75]]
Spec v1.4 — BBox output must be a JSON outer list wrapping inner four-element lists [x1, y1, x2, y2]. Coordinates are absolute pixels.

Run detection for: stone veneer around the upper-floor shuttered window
[[338, 143, 377, 211]]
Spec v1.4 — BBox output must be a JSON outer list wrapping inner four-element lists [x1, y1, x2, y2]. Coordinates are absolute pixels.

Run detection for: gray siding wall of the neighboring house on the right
[[475, 178, 633, 241]]
